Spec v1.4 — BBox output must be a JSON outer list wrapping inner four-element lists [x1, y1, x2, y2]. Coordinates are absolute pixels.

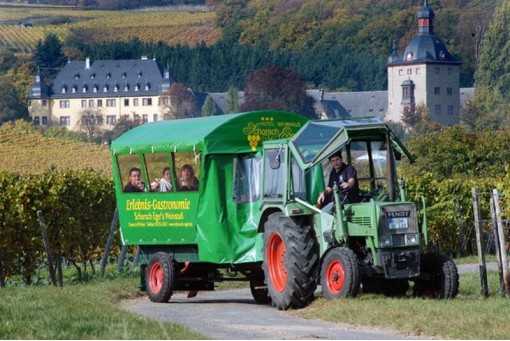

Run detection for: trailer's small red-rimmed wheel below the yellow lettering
[[145, 252, 175, 303]]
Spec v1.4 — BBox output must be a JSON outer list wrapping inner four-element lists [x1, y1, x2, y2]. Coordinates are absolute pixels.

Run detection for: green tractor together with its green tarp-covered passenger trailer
[[110, 111, 459, 310]]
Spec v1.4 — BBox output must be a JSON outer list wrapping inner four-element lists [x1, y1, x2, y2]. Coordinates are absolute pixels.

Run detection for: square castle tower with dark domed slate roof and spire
[[385, 0, 461, 125]]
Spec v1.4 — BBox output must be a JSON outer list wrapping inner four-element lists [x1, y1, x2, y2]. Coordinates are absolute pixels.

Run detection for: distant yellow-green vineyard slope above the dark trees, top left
[[0, 7, 221, 53]]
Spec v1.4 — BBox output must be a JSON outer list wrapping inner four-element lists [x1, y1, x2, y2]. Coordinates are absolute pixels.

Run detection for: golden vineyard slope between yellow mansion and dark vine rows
[[0, 121, 112, 175]]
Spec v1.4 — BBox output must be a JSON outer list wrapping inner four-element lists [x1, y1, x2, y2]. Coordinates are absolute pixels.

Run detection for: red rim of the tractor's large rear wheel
[[267, 233, 288, 292]]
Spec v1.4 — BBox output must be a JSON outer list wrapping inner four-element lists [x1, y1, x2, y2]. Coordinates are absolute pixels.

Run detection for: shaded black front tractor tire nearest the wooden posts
[[414, 253, 459, 299]]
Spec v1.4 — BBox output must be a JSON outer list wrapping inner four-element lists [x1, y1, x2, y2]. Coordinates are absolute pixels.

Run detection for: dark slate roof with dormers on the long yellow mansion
[[31, 57, 173, 98]]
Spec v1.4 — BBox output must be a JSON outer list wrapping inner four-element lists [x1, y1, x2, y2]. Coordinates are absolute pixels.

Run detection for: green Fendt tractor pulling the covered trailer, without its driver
[[260, 118, 459, 309]]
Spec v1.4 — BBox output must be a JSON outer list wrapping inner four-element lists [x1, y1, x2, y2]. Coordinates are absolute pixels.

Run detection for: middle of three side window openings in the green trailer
[[144, 153, 175, 193]]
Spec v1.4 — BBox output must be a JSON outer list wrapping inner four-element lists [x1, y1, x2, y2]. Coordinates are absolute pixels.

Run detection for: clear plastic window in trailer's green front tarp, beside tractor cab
[[232, 155, 262, 204]]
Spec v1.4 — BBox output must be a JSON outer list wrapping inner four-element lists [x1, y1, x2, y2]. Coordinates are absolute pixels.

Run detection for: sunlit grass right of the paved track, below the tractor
[[292, 271, 510, 340]]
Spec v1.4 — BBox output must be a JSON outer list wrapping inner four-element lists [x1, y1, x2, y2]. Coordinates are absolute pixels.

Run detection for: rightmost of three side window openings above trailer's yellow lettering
[[174, 151, 201, 192]]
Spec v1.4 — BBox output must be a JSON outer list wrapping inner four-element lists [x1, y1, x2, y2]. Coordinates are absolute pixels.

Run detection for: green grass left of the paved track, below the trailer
[[0, 277, 206, 340]]
